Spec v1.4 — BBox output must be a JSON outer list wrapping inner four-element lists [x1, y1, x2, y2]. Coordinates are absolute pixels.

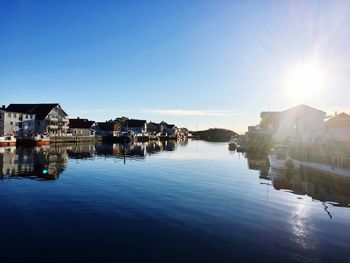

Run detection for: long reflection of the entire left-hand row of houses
[[0, 141, 185, 180]]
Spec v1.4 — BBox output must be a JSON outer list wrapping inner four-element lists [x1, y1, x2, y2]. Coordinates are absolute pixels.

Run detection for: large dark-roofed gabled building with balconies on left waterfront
[[6, 103, 69, 136]]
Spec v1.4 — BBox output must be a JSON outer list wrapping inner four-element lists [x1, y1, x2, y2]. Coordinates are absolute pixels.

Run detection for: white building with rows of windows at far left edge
[[0, 105, 35, 136]]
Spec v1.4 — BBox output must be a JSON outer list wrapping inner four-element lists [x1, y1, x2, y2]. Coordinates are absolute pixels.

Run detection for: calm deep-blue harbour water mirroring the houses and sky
[[0, 141, 350, 262]]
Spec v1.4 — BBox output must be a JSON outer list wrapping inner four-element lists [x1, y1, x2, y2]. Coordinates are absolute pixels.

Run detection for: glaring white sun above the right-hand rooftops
[[286, 62, 324, 103]]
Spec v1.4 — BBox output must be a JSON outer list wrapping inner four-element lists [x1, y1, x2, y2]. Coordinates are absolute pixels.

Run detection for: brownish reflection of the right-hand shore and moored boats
[[245, 152, 350, 208]]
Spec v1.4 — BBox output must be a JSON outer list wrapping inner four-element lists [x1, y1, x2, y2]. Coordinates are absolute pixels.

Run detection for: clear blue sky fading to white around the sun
[[0, 0, 350, 132]]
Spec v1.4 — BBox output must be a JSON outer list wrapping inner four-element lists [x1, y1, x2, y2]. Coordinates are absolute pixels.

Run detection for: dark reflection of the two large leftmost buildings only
[[0, 146, 68, 180]]
